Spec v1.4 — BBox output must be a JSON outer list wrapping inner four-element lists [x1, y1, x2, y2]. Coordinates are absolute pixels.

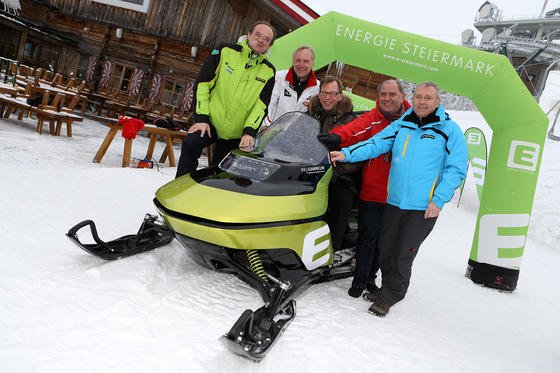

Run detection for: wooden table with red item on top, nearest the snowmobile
[[92, 115, 187, 167]]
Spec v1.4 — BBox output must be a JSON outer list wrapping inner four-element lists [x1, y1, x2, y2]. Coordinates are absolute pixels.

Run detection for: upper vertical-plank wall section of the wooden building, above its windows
[[41, 0, 290, 48]]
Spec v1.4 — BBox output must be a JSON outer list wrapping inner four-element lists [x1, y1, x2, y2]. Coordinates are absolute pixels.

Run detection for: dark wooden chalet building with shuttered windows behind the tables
[[0, 0, 319, 109]]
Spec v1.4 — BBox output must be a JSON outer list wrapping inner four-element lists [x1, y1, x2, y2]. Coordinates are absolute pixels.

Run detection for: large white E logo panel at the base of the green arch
[[477, 214, 529, 269]]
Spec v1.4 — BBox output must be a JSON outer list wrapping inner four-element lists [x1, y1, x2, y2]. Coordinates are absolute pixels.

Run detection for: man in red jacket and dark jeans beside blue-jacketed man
[[320, 79, 410, 298]]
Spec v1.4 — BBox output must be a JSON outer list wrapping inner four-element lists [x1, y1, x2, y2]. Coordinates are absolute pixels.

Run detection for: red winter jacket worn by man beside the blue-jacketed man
[[330, 100, 410, 203]]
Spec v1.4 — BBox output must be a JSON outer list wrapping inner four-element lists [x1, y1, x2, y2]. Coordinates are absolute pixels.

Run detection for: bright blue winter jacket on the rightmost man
[[342, 105, 469, 210]]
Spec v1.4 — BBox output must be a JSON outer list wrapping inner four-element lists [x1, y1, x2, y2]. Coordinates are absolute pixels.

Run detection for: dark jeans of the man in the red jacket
[[352, 200, 385, 289]]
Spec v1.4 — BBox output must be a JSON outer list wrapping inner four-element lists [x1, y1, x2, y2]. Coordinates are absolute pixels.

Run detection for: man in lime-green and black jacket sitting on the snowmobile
[[175, 21, 276, 177]]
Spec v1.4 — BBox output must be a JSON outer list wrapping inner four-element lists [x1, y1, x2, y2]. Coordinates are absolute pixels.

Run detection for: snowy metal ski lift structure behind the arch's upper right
[[461, 0, 560, 140]]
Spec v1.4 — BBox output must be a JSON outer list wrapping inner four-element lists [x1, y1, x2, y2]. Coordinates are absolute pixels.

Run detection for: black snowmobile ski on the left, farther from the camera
[[66, 214, 175, 260]]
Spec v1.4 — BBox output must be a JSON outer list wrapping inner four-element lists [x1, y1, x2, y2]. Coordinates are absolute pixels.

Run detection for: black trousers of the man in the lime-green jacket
[[175, 127, 240, 178]]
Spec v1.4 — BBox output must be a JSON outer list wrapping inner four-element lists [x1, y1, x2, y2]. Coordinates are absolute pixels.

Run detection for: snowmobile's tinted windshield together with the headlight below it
[[218, 112, 328, 181]]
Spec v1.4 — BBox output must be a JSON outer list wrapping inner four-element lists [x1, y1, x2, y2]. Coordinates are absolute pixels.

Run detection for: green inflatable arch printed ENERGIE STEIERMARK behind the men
[[271, 12, 548, 291]]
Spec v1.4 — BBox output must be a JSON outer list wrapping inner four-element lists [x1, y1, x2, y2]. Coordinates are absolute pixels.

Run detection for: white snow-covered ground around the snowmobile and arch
[[0, 105, 560, 372]]
